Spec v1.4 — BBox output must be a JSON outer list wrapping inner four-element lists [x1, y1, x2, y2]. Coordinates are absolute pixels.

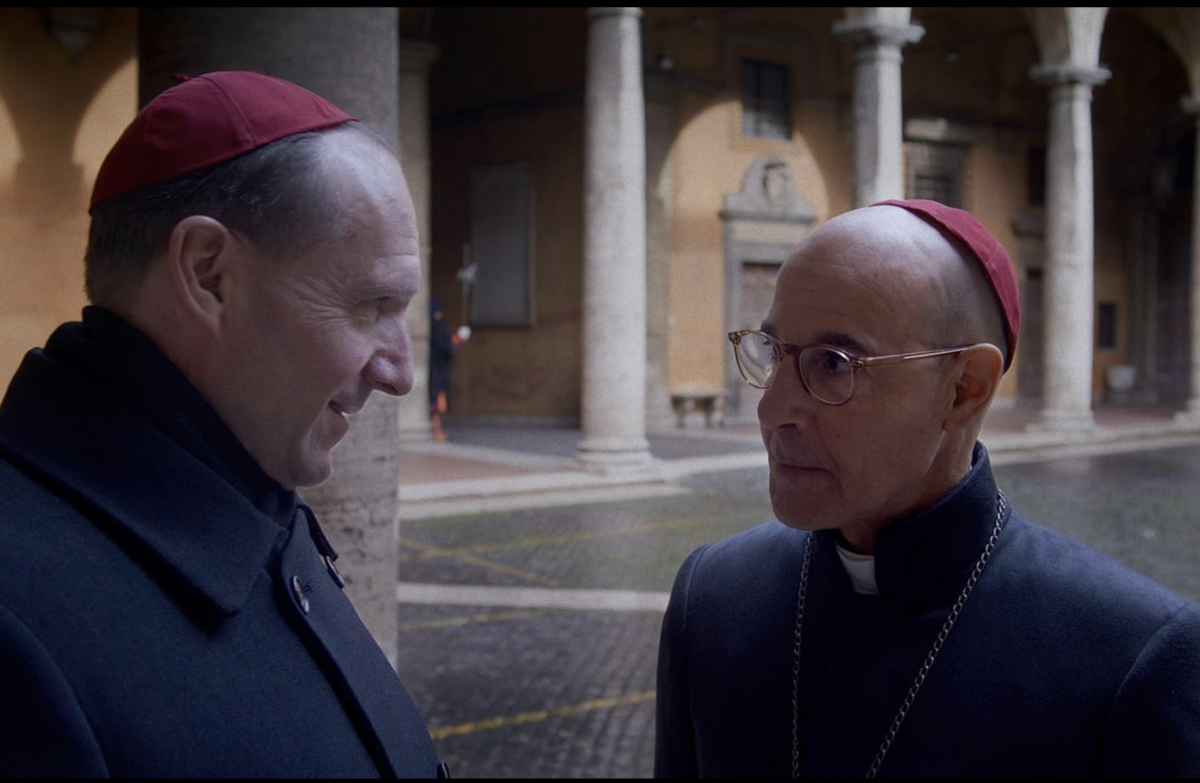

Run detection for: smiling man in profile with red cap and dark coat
[[0, 72, 445, 778]]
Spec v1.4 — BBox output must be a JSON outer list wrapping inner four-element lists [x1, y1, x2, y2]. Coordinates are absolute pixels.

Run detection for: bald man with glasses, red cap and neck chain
[[655, 201, 1200, 778]]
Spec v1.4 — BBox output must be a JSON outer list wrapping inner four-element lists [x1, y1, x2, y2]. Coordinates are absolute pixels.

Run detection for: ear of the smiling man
[[167, 215, 236, 331]]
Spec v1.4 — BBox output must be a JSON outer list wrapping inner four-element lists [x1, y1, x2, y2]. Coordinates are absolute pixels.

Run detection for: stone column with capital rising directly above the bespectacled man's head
[[833, 8, 925, 208]]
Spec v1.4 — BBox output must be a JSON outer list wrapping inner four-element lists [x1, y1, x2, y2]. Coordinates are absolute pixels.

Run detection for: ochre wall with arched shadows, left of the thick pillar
[[0, 7, 137, 387]]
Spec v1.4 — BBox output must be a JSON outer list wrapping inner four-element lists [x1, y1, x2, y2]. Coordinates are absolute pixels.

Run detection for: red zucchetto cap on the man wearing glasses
[[871, 198, 1021, 371]]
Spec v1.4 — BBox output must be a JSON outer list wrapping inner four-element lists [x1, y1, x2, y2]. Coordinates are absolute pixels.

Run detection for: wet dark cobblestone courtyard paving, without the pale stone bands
[[398, 447, 1200, 778]]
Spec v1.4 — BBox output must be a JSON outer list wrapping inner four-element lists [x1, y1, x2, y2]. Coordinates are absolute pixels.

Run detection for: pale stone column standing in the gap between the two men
[[578, 8, 650, 471]]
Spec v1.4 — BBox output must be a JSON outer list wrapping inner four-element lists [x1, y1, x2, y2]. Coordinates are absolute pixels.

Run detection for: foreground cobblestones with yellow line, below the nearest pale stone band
[[400, 606, 660, 778]]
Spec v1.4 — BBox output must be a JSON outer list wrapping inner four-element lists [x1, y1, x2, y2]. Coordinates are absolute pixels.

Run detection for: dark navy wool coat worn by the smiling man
[[0, 307, 438, 777]]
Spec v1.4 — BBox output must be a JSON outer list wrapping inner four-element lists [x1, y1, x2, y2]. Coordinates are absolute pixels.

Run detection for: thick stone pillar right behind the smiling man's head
[[138, 7, 405, 663]]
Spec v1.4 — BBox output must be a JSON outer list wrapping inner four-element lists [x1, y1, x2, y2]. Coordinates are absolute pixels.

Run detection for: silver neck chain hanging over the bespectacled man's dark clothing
[[792, 490, 1006, 779]]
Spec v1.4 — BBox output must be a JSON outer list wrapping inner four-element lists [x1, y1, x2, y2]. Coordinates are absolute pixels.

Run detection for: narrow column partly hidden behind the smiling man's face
[[400, 38, 438, 442]]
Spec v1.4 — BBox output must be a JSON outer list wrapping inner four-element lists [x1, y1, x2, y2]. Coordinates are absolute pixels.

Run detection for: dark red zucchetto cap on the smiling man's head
[[88, 71, 356, 213]]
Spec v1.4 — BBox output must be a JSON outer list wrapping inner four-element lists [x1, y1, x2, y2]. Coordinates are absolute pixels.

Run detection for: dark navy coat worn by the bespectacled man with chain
[[655, 447, 1200, 777]]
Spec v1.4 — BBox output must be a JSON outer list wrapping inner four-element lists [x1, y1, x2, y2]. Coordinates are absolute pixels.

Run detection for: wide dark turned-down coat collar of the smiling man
[[0, 307, 298, 614]]
